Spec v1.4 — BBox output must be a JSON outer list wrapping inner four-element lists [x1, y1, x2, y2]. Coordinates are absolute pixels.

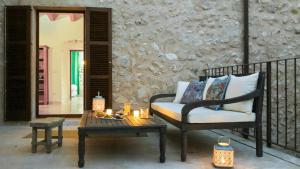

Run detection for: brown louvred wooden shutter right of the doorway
[[84, 8, 112, 110]]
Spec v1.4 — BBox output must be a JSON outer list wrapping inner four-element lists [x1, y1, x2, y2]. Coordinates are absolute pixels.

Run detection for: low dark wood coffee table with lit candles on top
[[78, 111, 167, 168]]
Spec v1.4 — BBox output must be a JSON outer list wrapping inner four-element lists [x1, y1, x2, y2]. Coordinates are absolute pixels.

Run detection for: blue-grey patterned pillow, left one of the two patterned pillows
[[180, 80, 206, 104]]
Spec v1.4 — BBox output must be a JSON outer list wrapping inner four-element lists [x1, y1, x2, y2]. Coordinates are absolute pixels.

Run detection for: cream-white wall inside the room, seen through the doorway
[[39, 15, 84, 103]]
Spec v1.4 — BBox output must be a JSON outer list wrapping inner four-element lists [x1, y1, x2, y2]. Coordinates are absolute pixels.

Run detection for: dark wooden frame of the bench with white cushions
[[149, 72, 265, 162]]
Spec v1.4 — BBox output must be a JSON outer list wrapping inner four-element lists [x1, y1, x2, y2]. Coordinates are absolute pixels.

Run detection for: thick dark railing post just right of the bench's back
[[267, 62, 272, 147]]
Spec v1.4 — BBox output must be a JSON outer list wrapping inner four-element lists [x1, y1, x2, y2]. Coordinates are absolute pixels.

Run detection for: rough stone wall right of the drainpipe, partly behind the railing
[[249, 0, 300, 150]]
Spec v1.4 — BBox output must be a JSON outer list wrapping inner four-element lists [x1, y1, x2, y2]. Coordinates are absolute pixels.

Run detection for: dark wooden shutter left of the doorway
[[5, 6, 31, 121]]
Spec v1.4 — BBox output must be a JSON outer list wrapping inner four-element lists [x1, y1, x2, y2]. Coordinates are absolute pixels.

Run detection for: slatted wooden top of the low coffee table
[[79, 111, 166, 129]]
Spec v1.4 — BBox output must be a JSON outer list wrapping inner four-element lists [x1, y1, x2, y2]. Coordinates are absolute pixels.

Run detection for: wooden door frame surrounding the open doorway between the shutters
[[33, 6, 86, 118]]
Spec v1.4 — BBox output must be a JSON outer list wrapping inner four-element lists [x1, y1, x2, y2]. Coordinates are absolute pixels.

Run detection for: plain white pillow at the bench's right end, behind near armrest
[[223, 73, 258, 113]]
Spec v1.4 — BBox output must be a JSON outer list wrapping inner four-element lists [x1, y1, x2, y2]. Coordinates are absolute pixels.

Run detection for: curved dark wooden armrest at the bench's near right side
[[181, 89, 261, 122]]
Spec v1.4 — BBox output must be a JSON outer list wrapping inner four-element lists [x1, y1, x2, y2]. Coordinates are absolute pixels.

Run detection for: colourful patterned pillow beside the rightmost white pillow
[[205, 76, 230, 110]]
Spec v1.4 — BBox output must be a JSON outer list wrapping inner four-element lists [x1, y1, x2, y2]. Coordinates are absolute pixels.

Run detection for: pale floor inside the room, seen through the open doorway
[[39, 97, 83, 115]]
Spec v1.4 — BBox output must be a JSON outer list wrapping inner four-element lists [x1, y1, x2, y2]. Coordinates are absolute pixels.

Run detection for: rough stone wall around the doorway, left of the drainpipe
[[0, 0, 242, 120]]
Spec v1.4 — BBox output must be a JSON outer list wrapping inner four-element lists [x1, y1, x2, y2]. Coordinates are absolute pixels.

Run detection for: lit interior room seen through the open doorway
[[38, 13, 84, 115]]
